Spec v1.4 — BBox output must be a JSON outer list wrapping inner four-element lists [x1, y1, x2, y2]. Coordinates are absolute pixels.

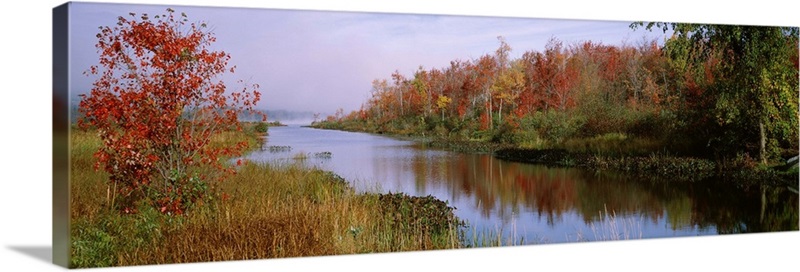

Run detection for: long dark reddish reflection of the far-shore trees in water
[[404, 148, 798, 233]]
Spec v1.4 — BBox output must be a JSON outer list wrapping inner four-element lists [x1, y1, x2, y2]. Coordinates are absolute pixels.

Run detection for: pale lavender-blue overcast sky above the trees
[[70, 3, 664, 115]]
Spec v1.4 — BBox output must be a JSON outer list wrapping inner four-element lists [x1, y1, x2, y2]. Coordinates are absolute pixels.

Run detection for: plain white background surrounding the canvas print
[[0, 0, 800, 271]]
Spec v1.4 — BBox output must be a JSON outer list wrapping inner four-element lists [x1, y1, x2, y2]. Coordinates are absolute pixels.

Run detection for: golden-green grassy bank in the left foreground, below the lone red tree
[[70, 127, 464, 267]]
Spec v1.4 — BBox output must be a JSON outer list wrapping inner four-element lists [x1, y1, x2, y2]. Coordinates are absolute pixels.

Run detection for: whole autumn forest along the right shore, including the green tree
[[304, 27, 800, 191]]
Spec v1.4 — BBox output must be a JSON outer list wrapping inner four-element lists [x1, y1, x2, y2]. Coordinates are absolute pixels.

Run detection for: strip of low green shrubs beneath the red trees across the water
[[310, 111, 672, 156]]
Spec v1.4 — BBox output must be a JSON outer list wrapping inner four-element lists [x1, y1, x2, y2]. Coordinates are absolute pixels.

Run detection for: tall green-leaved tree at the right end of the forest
[[631, 22, 798, 163]]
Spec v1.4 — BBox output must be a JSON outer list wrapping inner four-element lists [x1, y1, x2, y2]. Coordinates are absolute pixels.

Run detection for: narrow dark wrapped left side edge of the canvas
[[52, 2, 71, 267]]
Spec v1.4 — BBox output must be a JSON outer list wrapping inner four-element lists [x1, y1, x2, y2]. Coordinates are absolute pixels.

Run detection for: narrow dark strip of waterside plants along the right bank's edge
[[305, 124, 800, 188]]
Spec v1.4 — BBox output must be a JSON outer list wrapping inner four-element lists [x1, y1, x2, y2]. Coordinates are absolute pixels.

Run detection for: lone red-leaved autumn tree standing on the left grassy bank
[[80, 9, 266, 214]]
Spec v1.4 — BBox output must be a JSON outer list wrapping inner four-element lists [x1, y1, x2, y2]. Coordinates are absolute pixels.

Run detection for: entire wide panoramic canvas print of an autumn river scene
[[54, 2, 800, 268]]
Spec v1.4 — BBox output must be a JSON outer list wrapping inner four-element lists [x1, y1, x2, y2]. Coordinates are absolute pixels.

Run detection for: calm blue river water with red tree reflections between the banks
[[248, 126, 798, 244]]
